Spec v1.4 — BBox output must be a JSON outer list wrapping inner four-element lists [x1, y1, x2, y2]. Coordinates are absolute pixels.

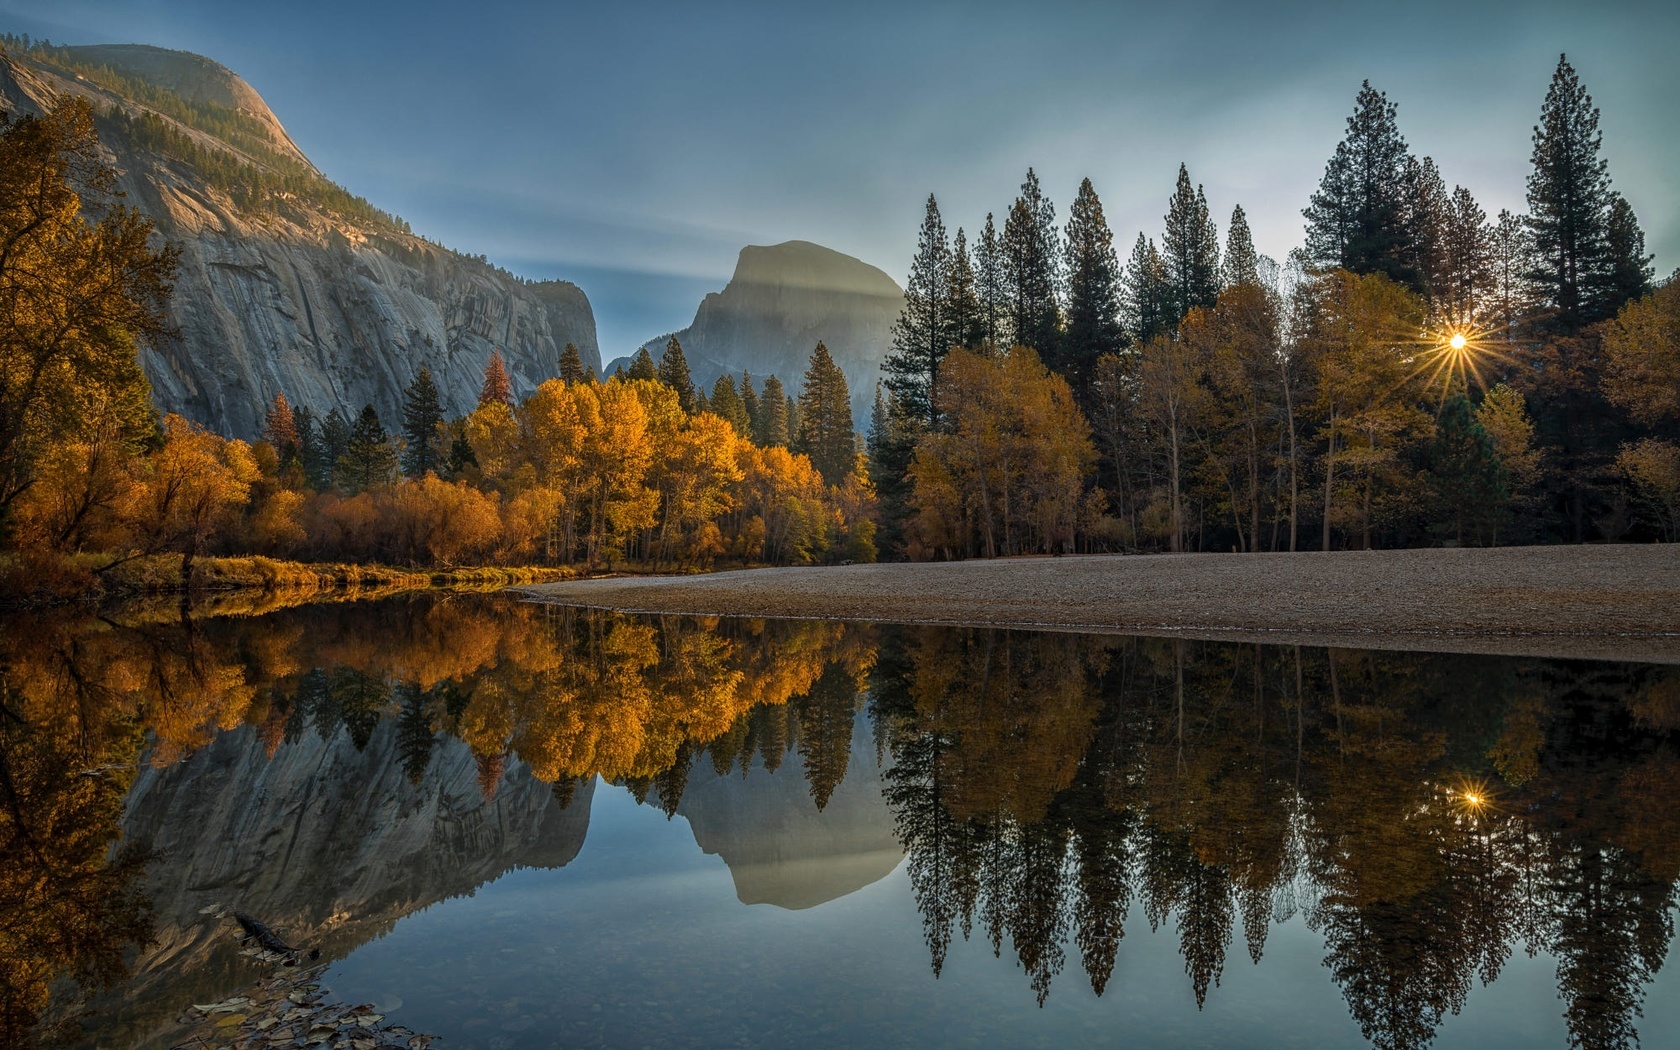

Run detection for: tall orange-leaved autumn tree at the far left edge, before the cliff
[[0, 99, 176, 539]]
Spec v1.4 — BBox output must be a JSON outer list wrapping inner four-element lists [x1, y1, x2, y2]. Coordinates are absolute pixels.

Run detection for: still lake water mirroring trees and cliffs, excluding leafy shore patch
[[0, 595, 1680, 1050]]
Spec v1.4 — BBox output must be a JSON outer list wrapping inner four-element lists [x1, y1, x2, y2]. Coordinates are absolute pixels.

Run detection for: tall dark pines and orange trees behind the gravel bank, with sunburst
[[869, 59, 1680, 558]]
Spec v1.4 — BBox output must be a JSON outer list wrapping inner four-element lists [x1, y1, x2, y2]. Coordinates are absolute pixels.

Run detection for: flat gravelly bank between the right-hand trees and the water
[[516, 544, 1680, 662]]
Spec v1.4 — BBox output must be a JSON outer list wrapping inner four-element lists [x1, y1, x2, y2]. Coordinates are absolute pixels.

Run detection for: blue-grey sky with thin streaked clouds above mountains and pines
[[0, 0, 1680, 360]]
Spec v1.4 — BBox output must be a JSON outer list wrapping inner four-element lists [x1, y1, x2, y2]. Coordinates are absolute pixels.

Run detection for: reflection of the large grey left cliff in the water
[[97, 719, 595, 1045]]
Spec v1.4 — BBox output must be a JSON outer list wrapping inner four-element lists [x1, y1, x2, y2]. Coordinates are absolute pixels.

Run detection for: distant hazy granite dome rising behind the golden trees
[[621, 240, 904, 420]]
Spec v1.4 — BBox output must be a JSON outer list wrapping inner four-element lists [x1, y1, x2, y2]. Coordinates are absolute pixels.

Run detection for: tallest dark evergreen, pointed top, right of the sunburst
[[1529, 55, 1614, 331]]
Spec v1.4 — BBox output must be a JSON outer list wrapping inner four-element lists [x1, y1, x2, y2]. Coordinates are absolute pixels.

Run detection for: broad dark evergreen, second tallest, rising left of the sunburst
[[1304, 81, 1416, 289]]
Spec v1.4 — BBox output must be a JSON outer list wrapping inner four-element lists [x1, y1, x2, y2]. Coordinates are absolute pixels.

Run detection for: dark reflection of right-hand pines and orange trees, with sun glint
[[872, 628, 1680, 1047]]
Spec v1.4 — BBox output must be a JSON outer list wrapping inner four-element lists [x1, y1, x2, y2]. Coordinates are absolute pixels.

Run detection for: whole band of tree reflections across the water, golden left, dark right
[[0, 596, 1680, 1047]]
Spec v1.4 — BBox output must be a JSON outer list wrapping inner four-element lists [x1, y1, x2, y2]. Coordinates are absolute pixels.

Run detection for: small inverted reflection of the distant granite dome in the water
[[677, 716, 904, 909]]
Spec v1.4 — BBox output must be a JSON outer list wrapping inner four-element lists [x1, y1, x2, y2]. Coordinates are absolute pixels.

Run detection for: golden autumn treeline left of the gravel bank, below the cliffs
[[0, 99, 875, 590]]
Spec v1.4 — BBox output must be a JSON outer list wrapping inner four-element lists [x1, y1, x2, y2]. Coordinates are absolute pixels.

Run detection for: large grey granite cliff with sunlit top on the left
[[0, 45, 600, 437]]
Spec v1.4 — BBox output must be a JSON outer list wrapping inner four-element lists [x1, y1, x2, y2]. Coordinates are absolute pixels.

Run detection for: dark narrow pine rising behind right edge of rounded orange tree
[[1052, 178, 1126, 400]]
